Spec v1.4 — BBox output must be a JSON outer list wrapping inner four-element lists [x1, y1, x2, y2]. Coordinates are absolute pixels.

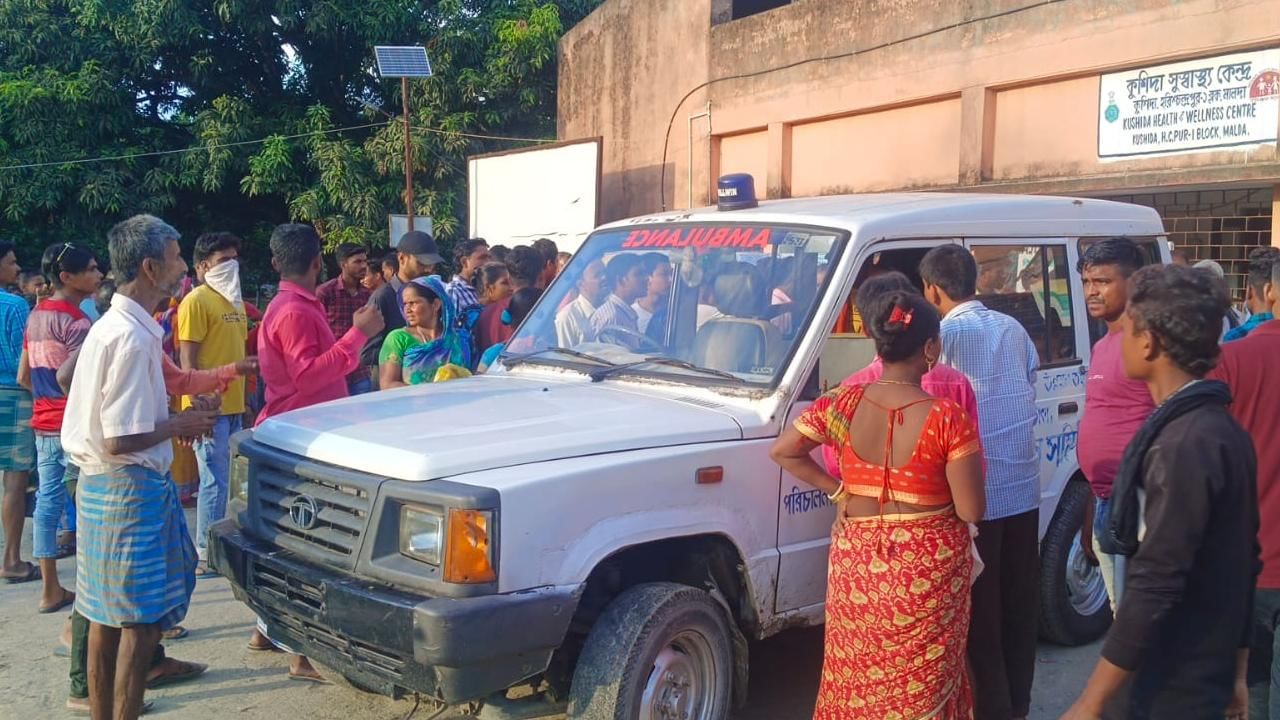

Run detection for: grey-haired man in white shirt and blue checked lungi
[[61, 215, 218, 720]]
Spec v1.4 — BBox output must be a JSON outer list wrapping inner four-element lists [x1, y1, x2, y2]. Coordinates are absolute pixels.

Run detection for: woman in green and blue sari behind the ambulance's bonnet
[[378, 275, 472, 389]]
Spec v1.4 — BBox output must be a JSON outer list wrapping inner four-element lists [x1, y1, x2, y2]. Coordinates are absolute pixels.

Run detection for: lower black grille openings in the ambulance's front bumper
[[250, 562, 410, 683]]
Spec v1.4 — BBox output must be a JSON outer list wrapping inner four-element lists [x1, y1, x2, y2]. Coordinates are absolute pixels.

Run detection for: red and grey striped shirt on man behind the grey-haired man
[[23, 300, 90, 433]]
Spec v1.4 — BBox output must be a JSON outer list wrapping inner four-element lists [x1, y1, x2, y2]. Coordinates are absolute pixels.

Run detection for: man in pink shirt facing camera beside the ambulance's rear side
[[1076, 237, 1156, 611]]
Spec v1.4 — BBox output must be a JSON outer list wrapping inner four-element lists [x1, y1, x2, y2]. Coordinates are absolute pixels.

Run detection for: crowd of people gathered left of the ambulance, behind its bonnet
[[0, 215, 564, 719]]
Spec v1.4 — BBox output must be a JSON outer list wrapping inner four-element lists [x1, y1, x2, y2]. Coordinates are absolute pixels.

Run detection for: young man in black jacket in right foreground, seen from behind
[[1064, 265, 1261, 720]]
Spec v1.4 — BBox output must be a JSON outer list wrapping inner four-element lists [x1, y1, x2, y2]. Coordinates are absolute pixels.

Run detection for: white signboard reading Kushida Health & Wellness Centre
[[1098, 49, 1280, 159]]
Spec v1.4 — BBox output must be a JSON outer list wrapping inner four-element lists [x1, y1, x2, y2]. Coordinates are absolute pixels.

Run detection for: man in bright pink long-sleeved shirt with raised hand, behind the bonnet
[[248, 224, 385, 683]]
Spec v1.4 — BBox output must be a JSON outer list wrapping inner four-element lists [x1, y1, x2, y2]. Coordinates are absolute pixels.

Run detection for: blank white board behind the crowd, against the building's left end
[[467, 138, 600, 252]]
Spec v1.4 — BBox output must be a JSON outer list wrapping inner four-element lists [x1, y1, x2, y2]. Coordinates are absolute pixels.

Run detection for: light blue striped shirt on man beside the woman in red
[[941, 300, 1039, 520]]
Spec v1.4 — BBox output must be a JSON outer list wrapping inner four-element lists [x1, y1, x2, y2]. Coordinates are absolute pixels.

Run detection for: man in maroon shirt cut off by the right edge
[[1210, 263, 1280, 717]]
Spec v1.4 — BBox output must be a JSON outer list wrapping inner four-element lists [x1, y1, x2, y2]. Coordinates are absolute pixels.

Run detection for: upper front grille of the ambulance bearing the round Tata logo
[[253, 462, 374, 568]]
